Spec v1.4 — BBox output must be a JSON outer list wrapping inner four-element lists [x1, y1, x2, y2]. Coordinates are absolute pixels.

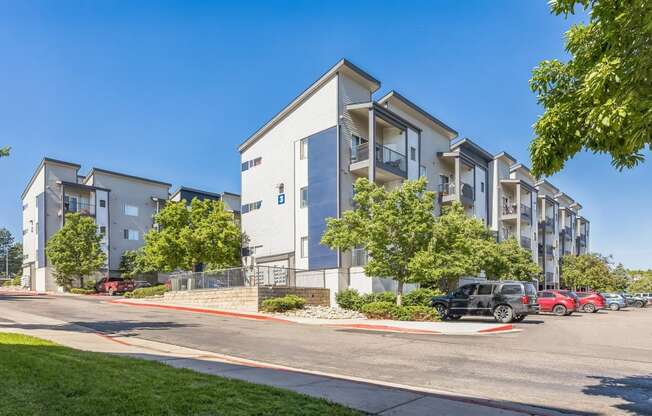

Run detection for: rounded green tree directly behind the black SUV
[[410, 203, 495, 290]]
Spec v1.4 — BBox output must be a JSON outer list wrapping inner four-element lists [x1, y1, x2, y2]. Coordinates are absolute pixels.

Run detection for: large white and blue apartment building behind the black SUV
[[239, 60, 588, 295]]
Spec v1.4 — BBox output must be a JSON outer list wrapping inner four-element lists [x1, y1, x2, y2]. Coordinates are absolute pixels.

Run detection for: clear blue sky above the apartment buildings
[[0, 0, 652, 268]]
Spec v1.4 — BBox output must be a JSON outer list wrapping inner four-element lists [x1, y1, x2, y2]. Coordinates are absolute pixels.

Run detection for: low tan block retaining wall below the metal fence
[[161, 286, 330, 312]]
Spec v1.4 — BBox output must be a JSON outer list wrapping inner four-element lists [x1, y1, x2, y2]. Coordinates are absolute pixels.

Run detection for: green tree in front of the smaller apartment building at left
[[45, 213, 106, 288]]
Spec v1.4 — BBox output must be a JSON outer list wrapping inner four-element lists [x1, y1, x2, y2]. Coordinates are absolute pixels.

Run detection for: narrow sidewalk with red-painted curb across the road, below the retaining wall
[[111, 299, 521, 335]]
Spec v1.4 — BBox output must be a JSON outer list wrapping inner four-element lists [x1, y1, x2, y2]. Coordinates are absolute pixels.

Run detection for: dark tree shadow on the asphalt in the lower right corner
[[582, 375, 652, 415]]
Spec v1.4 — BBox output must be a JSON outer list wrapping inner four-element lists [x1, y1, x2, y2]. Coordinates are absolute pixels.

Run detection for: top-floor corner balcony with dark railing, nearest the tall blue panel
[[350, 143, 407, 181]]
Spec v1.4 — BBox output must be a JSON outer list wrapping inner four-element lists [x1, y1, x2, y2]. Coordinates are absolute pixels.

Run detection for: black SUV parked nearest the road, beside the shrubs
[[430, 280, 539, 323]]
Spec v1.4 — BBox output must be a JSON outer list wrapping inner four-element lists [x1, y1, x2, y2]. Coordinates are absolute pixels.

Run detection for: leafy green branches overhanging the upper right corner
[[530, 0, 652, 175]]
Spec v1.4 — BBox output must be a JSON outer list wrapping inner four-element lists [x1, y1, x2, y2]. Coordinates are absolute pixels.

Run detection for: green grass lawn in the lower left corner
[[0, 333, 359, 416]]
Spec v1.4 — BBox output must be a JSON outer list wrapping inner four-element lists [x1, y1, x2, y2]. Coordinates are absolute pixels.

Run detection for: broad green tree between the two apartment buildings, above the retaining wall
[[141, 198, 242, 272]]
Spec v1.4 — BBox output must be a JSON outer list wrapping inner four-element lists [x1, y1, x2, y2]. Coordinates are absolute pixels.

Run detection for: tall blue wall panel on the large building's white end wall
[[308, 127, 337, 269]]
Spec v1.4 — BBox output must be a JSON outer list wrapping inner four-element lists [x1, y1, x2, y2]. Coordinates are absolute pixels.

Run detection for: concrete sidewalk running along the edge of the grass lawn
[[0, 309, 559, 416]]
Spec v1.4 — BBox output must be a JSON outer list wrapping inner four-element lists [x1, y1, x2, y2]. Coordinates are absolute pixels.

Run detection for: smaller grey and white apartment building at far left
[[21, 158, 171, 292]]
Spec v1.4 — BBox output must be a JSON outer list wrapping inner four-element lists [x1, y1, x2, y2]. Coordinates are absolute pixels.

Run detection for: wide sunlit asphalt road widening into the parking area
[[0, 295, 652, 415]]
